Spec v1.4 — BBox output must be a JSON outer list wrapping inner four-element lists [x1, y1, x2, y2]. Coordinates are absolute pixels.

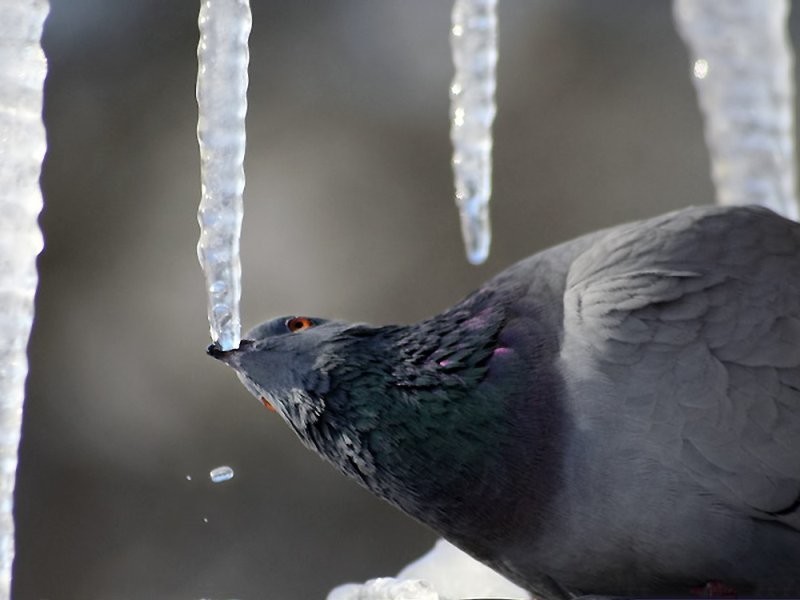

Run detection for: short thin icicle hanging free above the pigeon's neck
[[450, 0, 497, 264]]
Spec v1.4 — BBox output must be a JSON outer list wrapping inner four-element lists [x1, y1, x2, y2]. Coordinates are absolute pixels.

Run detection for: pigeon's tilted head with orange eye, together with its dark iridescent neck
[[208, 296, 540, 532]]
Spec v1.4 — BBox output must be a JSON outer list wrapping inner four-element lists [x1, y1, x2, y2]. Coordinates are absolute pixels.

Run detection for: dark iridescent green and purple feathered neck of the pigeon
[[310, 295, 564, 554]]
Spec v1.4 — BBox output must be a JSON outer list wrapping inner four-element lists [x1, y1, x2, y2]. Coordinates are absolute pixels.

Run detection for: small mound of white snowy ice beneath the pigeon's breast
[[327, 540, 531, 600]]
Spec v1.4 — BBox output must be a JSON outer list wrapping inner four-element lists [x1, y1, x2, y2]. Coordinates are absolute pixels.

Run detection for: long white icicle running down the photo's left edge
[[0, 0, 48, 600]]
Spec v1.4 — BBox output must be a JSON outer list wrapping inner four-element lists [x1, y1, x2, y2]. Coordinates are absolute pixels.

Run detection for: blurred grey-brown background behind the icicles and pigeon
[[14, 0, 797, 600]]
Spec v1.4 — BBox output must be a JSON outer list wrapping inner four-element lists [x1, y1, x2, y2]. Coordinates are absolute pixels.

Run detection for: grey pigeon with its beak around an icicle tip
[[208, 206, 800, 600]]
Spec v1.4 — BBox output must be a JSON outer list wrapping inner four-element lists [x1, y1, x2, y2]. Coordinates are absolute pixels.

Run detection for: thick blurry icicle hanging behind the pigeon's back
[[673, 0, 798, 219]]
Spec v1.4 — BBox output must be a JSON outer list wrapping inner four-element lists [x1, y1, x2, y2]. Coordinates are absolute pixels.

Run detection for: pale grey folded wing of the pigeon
[[561, 207, 800, 529]]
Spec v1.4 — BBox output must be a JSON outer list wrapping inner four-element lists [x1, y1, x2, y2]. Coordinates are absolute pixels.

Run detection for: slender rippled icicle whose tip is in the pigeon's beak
[[197, 0, 252, 350]]
